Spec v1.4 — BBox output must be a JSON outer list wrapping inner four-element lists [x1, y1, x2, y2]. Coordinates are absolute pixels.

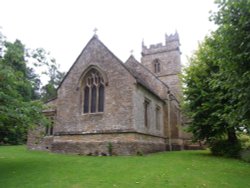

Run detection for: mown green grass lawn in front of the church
[[0, 146, 250, 188]]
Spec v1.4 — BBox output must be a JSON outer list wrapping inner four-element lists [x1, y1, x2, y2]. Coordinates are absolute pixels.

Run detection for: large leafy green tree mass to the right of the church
[[184, 0, 250, 156]]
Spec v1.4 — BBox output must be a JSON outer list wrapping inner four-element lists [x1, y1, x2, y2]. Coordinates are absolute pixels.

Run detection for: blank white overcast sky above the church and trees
[[0, 0, 216, 71]]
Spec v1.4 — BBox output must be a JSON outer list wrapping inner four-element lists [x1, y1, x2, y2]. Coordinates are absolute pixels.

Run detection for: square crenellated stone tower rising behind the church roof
[[141, 32, 182, 99]]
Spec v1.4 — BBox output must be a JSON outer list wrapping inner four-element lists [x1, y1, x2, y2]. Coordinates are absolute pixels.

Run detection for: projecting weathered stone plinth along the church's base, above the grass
[[52, 133, 166, 155]]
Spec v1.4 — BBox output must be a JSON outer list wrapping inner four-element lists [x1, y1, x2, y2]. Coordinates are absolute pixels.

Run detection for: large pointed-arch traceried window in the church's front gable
[[83, 69, 105, 114]]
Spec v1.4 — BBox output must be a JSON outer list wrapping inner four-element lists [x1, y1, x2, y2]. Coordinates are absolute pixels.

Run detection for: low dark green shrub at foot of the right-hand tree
[[210, 140, 241, 158]]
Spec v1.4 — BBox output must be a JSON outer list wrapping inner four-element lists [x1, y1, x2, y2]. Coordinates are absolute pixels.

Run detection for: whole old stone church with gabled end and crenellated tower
[[27, 33, 190, 155]]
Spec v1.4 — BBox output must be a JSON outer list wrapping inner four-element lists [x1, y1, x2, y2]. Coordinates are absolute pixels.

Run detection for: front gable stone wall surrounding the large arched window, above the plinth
[[54, 37, 135, 133]]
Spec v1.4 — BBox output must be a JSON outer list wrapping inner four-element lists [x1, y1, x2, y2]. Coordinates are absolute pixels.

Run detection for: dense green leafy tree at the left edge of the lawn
[[0, 37, 48, 144]]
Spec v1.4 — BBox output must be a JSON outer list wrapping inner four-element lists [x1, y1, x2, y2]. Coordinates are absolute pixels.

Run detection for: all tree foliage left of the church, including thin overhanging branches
[[0, 33, 64, 144]]
